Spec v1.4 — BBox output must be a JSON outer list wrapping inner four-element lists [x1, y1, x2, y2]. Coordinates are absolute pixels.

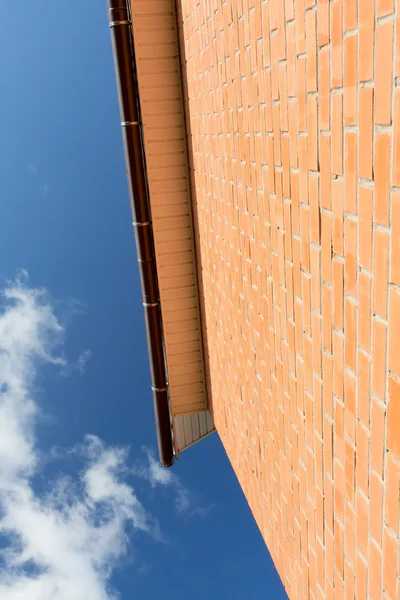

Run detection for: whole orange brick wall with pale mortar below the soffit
[[178, 0, 400, 600]]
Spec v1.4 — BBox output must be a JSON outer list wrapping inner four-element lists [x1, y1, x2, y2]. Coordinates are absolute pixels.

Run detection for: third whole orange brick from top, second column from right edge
[[372, 229, 389, 319]]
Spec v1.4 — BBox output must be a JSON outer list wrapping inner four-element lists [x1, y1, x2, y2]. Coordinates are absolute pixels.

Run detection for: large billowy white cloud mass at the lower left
[[0, 274, 162, 600]]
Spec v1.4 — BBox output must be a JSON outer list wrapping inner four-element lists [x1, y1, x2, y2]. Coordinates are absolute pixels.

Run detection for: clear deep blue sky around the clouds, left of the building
[[0, 0, 286, 600]]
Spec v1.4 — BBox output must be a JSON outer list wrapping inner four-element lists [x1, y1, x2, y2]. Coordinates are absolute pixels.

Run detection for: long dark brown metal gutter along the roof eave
[[107, 0, 174, 467]]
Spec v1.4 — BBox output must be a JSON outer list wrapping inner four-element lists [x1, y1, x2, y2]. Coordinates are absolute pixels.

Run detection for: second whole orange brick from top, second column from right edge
[[374, 133, 391, 227]]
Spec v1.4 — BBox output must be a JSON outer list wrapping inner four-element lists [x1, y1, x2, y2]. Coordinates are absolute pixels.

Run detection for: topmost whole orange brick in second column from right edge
[[375, 21, 393, 125]]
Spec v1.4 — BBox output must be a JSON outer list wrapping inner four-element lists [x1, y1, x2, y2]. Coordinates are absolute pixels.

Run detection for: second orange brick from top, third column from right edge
[[358, 88, 374, 179]]
